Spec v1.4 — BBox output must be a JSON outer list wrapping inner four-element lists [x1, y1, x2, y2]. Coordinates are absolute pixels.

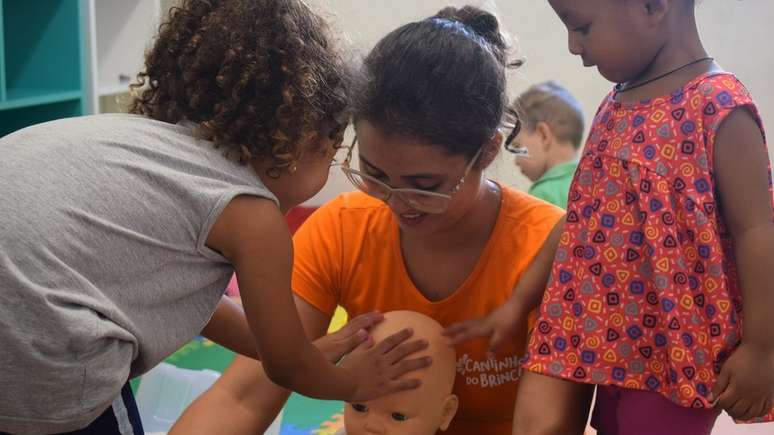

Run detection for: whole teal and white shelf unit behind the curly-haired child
[[0, 0, 179, 137]]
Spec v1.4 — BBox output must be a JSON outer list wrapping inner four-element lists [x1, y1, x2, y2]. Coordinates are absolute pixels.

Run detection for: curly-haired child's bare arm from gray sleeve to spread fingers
[[207, 196, 429, 401]]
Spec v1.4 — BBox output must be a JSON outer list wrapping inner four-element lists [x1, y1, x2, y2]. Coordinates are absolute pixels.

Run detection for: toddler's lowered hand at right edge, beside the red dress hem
[[707, 340, 774, 420]]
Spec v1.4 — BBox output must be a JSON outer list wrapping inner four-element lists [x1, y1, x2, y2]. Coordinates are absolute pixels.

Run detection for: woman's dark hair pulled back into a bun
[[354, 6, 521, 158]]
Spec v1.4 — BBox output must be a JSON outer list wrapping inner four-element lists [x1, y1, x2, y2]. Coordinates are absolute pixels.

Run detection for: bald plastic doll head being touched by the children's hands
[[344, 311, 459, 435]]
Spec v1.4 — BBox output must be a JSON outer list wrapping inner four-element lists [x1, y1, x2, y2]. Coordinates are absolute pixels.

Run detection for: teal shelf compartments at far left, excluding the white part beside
[[0, 0, 88, 137]]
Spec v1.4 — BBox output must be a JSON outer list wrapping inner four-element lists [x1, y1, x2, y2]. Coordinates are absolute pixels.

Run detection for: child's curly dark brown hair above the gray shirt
[[130, 0, 351, 169]]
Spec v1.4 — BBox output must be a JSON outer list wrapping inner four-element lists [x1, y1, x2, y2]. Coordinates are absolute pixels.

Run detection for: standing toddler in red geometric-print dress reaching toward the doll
[[447, 0, 774, 435]]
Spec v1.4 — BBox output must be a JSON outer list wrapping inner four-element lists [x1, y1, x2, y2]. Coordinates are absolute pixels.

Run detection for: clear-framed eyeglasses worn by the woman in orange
[[341, 137, 483, 214]]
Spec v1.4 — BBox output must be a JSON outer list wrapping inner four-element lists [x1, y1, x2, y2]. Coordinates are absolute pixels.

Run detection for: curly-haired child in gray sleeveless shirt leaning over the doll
[[0, 0, 429, 434]]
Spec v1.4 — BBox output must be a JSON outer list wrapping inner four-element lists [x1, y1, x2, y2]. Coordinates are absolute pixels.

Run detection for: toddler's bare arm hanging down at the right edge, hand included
[[709, 109, 774, 420]]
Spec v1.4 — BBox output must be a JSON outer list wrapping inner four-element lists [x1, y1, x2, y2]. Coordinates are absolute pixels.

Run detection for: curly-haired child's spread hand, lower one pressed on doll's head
[[339, 329, 432, 403]]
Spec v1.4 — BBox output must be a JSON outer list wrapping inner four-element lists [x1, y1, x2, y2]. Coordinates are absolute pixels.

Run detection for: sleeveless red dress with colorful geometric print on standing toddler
[[525, 73, 774, 422]]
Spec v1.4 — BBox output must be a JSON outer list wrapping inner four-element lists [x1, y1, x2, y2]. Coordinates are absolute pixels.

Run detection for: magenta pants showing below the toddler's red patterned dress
[[591, 385, 720, 435]]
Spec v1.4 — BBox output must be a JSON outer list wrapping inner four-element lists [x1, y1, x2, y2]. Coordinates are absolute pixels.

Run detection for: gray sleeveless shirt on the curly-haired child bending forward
[[0, 115, 277, 378]]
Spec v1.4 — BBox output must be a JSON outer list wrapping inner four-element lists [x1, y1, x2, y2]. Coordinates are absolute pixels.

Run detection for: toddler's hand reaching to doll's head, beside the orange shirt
[[444, 301, 528, 354]]
